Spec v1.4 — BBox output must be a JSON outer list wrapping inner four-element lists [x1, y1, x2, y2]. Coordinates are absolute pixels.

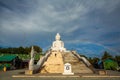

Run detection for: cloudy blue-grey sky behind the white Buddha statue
[[0, 0, 120, 57]]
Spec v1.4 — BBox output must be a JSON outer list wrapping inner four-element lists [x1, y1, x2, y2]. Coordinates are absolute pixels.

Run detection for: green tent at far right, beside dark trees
[[103, 59, 119, 70]]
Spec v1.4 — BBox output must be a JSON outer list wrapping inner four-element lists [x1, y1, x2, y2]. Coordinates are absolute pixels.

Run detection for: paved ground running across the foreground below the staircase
[[0, 69, 120, 80]]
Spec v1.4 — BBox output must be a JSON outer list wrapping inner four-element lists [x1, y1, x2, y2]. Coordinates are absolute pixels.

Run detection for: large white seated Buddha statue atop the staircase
[[51, 33, 66, 51]]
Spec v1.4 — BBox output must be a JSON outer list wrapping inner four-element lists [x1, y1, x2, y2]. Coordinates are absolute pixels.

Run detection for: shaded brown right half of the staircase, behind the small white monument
[[63, 52, 93, 73]]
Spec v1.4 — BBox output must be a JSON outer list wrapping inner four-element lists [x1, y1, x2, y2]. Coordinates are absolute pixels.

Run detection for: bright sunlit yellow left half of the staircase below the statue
[[40, 51, 64, 73]]
